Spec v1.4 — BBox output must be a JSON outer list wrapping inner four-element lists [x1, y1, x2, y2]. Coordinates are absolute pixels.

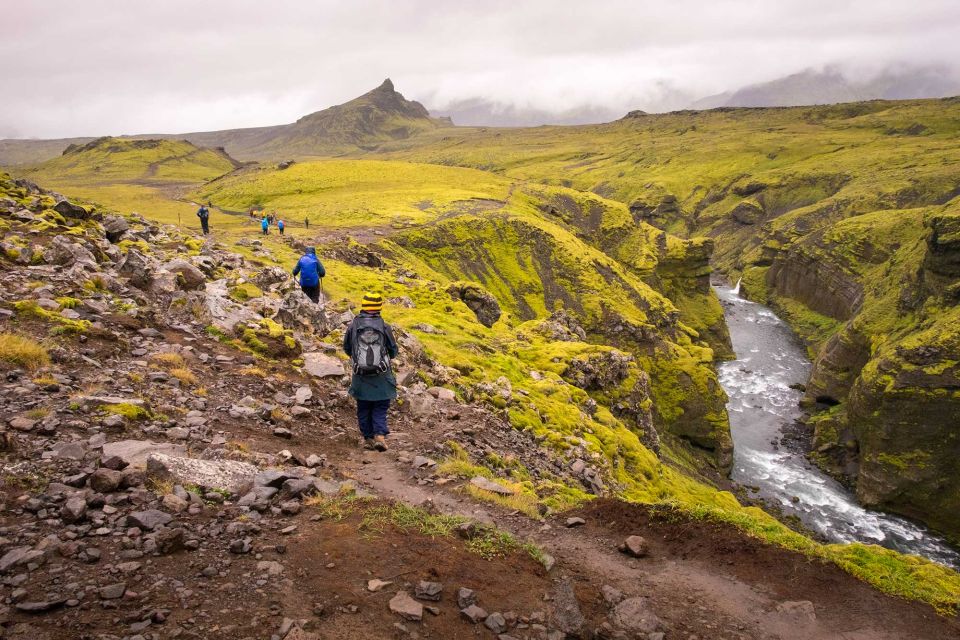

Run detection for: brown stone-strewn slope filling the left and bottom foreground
[[0, 177, 957, 640]]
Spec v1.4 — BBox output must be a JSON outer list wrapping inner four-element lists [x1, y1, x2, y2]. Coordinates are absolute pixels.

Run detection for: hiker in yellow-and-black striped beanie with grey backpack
[[343, 293, 397, 451]]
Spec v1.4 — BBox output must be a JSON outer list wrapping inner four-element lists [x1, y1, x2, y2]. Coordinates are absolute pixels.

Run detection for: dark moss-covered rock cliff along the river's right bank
[[761, 205, 960, 537]]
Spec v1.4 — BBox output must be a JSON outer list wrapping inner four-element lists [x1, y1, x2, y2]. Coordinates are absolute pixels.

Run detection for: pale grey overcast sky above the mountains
[[0, 0, 960, 138]]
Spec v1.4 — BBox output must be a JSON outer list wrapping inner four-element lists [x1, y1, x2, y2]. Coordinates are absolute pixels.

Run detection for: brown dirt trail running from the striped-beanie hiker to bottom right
[[347, 448, 960, 640]]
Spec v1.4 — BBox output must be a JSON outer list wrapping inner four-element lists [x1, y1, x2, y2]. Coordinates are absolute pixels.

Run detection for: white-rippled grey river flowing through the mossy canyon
[[715, 285, 960, 568]]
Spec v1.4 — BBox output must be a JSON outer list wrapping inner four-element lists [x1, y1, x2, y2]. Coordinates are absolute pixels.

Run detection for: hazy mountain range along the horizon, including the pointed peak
[[0, 68, 960, 166]]
